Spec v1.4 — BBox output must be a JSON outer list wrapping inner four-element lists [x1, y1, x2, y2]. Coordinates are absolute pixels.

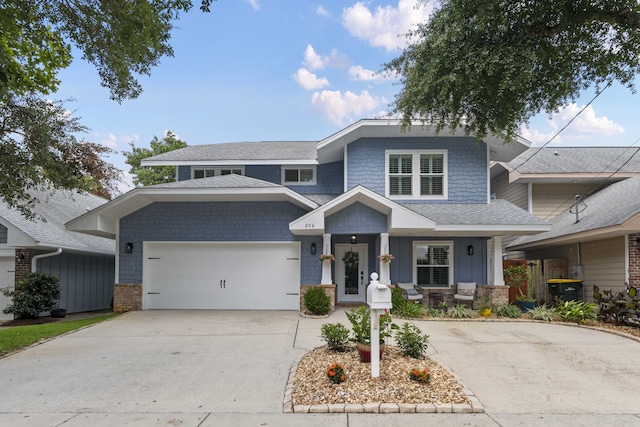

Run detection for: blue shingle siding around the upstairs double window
[[347, 137, 488, 203]]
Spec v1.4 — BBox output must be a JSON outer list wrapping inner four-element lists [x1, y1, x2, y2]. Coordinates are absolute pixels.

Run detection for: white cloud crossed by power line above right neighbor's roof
[[521, 102, 624, 145]]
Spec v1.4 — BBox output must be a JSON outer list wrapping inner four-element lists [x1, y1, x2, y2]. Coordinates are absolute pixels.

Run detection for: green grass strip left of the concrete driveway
[[0, 314, 118, 356]]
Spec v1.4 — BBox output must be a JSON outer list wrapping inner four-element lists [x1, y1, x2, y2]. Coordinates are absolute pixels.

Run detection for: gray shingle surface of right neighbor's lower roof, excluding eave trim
[[511, 177, 640, 246]]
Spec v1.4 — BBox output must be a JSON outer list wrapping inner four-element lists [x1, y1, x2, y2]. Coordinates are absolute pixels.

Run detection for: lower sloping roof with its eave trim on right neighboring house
[[509, 177, 640, 250]]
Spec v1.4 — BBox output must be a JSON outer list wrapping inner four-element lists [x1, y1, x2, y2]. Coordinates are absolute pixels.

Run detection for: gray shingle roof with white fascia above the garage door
[[66, 174, 318, 237]]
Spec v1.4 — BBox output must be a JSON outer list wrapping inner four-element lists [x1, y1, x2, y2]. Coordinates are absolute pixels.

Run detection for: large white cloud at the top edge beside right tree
[[342, 0, 432, 51]]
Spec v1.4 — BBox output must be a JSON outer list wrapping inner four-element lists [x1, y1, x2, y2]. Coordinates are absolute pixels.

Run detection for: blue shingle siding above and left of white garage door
[[119, 202, 309, 283]]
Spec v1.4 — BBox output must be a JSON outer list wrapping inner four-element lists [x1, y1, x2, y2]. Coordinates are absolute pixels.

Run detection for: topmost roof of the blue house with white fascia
[[141, 119, 530, 166]]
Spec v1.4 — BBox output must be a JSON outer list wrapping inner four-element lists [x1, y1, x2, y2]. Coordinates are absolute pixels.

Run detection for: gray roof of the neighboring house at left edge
[[0, 190, 115, 254]]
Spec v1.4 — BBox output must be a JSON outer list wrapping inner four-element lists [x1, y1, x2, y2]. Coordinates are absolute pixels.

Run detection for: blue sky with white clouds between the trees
[[53, 0, 640, 192]]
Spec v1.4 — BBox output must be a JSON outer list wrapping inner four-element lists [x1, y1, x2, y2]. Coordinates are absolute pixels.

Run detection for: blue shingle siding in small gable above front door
[[324, 203, 387, 234]]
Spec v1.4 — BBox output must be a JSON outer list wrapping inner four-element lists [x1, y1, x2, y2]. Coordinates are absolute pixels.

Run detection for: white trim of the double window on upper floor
[[384, 150, 449, 200]]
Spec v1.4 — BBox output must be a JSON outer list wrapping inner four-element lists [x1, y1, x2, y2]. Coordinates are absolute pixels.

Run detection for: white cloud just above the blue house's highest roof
[[311, 90, 385, 126]]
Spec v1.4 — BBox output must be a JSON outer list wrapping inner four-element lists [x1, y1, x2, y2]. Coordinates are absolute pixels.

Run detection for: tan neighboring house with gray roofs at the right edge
[[491, 147, 640, 299]]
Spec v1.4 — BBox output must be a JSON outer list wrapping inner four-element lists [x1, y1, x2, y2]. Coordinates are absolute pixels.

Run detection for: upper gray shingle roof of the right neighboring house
[[508, 147, 640, 174]]
